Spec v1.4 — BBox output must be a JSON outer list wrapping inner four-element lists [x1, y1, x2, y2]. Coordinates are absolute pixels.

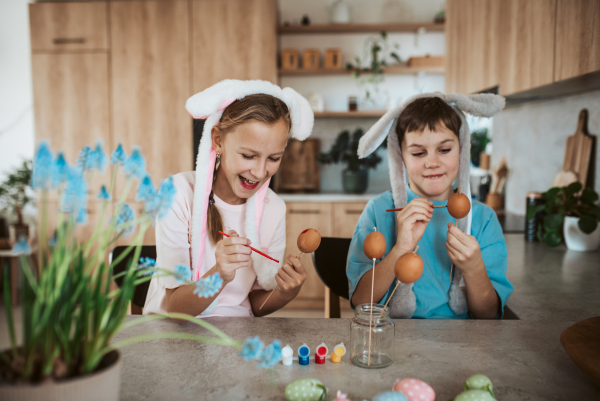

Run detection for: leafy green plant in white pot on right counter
[[527, 182, 600, 251]]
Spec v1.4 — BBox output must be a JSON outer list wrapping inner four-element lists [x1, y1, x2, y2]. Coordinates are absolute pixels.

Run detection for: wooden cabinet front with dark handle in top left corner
[[29, 1, 108, 53]]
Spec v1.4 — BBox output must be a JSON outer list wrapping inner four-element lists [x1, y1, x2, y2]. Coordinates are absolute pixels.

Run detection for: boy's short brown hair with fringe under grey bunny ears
[[396, 97, 462, 146]]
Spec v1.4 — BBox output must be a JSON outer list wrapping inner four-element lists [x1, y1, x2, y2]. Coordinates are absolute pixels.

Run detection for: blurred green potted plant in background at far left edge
[[0, 160, 33, 238]]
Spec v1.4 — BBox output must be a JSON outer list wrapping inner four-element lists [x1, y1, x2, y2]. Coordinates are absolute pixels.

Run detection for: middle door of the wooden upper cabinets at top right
[[500, 0, 556, 95]]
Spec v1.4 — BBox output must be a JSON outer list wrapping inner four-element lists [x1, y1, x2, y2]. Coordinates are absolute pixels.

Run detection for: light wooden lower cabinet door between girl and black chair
[[285, 202, 332, 309]]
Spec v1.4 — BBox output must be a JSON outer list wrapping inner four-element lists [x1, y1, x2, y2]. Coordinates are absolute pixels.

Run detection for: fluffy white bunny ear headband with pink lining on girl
[[185, 79, 314, 289]]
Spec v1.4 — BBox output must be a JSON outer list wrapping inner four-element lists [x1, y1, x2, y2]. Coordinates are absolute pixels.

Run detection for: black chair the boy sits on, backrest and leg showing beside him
[[312, 237, 519, 320]]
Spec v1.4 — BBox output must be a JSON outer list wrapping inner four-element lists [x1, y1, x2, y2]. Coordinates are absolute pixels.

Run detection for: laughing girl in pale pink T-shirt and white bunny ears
[[144, 80, 314, 317]]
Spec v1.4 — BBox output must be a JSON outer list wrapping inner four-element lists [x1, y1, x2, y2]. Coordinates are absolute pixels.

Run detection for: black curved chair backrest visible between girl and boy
[[313, 237, 351, 299]]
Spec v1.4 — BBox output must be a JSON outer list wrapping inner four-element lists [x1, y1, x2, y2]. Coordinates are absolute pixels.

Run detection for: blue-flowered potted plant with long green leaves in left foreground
[[0, 143, 281, 400]]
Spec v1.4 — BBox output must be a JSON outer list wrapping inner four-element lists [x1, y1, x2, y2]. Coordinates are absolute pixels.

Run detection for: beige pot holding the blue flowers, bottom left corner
[[0, 351, 121, 401]]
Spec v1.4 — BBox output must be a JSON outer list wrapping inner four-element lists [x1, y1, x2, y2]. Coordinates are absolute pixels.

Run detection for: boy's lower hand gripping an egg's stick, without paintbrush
[[446, 223, 485, 276]]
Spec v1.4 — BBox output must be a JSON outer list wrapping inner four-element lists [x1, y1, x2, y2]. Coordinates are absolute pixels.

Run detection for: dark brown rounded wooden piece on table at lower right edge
[[560, 316, 600, 386]]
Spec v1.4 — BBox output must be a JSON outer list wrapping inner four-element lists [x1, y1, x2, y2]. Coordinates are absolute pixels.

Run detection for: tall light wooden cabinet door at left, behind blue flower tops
[[31, 53, 112, 199]]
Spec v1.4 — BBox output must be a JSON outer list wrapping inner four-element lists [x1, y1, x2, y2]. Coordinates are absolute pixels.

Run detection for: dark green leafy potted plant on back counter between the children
[[317, 128, 387, 194]]
